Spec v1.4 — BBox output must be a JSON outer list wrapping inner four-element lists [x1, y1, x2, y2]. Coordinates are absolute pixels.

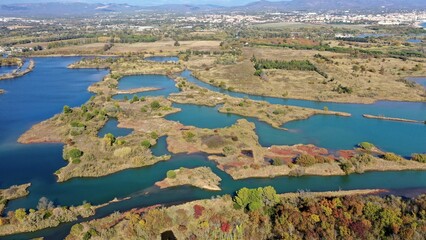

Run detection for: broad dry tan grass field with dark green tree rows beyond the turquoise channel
[[188, 47, 426, 103]]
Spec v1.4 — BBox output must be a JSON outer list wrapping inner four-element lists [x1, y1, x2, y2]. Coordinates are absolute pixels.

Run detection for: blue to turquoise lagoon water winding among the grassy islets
[[0, 58, 426, 239]]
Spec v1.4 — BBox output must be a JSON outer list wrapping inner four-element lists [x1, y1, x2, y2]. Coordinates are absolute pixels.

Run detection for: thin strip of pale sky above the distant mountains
[[0, 0, 288, 6]]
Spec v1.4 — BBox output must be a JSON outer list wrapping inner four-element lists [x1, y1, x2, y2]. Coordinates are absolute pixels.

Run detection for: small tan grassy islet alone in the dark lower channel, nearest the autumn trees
[[155, 167, 222, 191]]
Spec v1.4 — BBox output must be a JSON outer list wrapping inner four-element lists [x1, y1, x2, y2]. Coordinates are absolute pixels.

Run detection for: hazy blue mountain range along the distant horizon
[[0, 0, 426, 17]]
